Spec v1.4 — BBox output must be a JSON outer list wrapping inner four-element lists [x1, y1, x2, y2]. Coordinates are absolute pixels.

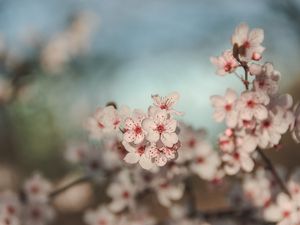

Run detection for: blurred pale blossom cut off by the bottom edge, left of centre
[[84, 206, 117, 225]]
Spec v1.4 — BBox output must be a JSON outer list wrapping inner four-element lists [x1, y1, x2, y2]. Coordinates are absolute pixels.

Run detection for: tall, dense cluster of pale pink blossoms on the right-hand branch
[[211, 24, 298, 175]]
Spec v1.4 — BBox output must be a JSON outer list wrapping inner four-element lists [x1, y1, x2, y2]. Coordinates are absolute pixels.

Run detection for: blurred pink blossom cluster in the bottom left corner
[[0, 174, 55, 225]]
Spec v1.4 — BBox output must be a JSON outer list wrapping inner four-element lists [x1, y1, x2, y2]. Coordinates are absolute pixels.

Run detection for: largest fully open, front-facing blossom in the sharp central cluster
[[142, 110, 178, 147]]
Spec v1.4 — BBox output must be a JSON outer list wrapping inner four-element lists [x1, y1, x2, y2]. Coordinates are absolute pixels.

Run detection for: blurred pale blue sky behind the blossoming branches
[[0, 0, 300, 134]]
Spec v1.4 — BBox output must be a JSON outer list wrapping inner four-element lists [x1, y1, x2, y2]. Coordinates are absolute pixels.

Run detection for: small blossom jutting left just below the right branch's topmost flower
[[210, 50, 239, 76]]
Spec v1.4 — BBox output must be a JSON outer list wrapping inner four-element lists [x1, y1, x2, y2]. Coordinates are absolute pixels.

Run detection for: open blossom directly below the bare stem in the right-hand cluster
[[237, 91, 270, 120]]
